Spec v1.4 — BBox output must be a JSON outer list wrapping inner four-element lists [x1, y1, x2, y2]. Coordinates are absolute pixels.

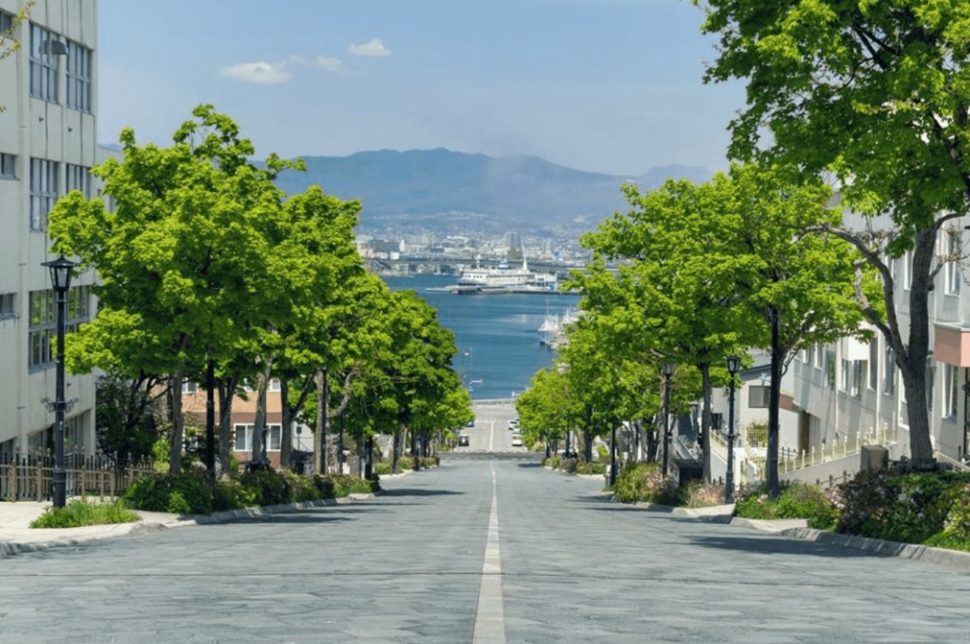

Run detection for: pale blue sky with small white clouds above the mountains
[[99, 0, 743, 175]]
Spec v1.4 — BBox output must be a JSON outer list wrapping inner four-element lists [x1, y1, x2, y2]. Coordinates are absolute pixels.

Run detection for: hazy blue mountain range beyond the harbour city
[[278, 148, 711, 230]]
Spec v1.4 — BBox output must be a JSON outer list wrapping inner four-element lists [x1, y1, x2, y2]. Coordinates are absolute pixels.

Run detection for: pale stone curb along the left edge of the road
[[0, 493, 375, 559]]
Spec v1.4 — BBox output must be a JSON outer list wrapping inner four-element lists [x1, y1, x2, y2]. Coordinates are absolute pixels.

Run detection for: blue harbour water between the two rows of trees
[[384, 275, 579, 400]]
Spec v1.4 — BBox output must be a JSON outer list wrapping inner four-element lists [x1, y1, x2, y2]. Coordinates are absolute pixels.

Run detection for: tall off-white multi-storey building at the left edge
[[0, 0, 98, 455]]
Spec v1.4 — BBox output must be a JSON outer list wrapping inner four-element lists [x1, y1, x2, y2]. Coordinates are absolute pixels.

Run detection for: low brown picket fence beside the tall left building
[[0, 451, 154, 501]]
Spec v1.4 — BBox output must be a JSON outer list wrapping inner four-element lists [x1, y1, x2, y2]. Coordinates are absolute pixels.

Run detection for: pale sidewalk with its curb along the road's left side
[[0, 494, 374, 559]]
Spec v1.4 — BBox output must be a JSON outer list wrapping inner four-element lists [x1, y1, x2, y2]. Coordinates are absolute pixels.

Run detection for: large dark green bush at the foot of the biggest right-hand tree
[[838, 470, 970, 543]]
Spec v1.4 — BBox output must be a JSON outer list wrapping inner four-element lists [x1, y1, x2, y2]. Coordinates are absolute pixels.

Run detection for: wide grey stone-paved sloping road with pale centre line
[[0, 460, 970, 643]]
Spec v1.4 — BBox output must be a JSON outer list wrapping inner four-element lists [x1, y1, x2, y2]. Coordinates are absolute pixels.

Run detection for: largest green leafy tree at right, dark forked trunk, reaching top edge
[[695, 0, 970, 466]]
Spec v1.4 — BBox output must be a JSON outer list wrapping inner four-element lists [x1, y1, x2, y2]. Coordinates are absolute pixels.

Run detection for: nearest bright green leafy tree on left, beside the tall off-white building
[[50, 105, 294, 472]]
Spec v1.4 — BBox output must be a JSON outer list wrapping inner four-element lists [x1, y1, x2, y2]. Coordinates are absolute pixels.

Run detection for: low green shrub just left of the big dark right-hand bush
[[734, 483, 839, 530]]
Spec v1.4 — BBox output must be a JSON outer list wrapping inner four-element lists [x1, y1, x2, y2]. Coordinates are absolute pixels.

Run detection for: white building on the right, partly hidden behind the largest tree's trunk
[[793, 220, 970, 460]]
